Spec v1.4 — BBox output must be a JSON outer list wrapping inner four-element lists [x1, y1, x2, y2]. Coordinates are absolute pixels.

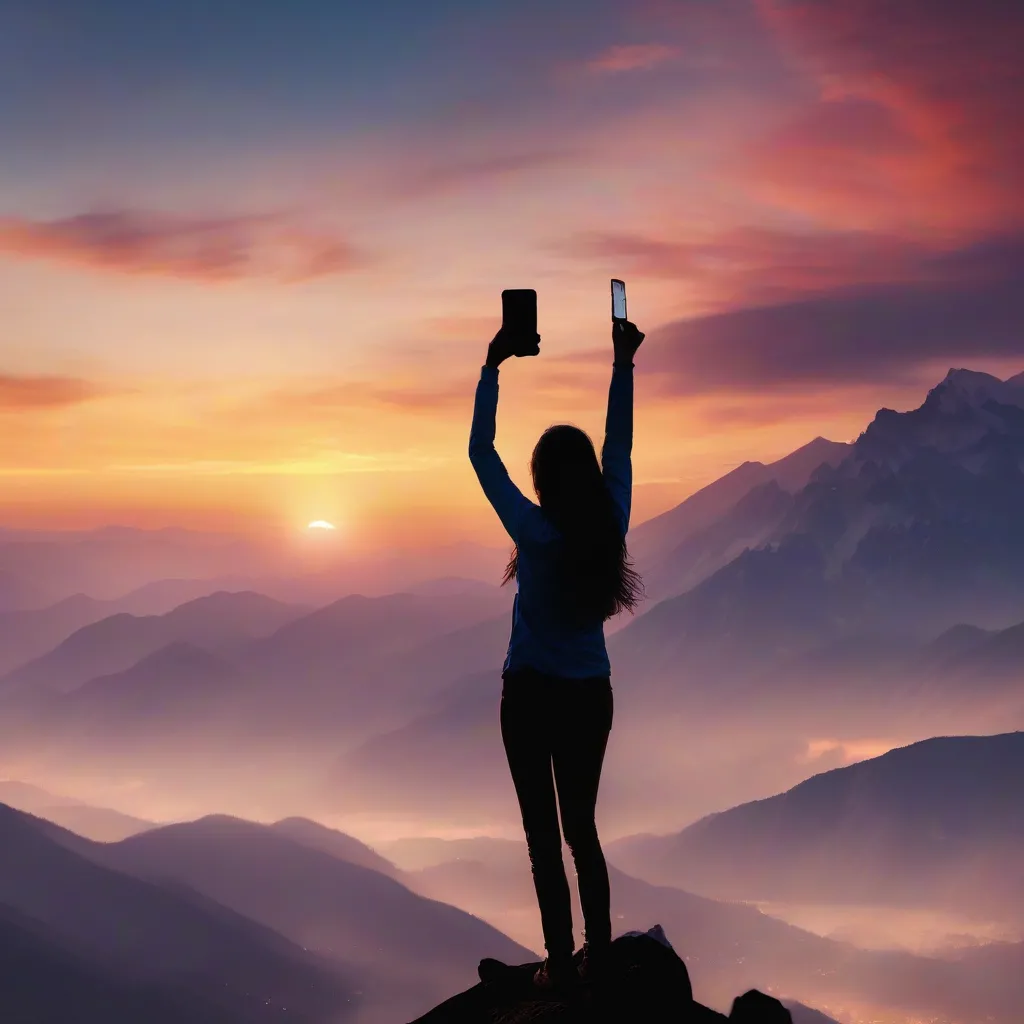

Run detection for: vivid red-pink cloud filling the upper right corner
[[742, 0, 1024, 237]]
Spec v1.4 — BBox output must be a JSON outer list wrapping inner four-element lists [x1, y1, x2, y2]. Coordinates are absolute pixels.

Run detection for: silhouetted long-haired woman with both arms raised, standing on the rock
[[469, 321, 644, 988]]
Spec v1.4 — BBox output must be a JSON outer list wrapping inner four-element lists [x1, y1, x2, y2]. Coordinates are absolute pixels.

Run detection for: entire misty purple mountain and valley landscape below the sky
[[0, 371, 1024, 1024]]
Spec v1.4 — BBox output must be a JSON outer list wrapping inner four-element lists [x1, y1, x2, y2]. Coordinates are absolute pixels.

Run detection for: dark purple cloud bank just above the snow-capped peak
[[644, 234, 1024, 394]]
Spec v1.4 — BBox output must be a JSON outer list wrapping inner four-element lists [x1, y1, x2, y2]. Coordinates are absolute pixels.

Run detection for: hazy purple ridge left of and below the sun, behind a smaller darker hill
[[3, 592, 307, 691]]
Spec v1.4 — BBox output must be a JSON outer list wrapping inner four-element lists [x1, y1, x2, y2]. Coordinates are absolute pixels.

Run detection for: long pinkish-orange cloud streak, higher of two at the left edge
[[0, 210, 360, 282]]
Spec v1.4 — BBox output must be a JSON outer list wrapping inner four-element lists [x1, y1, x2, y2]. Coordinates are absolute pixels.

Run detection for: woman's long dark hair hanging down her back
[[502, 424, 643, 625]]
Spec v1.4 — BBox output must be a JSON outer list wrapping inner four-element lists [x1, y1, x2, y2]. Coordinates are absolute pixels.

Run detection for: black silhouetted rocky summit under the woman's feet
[[413, 926, 793, 1024]]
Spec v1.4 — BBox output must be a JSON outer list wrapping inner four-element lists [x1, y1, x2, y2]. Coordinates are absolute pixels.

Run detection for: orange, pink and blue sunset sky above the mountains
[[0, 0, 1024, 546]]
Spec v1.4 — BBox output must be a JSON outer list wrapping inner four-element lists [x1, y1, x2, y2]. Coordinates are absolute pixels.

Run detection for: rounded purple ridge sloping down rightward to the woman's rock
[[94, 817, 529, 1019]]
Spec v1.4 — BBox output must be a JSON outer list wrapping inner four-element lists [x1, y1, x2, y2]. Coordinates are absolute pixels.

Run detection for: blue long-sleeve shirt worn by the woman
[[469, 365, 633, 679]]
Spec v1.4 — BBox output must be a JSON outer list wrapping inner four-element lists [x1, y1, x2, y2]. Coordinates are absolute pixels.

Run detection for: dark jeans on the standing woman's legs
[[501, 671, 612, 956]]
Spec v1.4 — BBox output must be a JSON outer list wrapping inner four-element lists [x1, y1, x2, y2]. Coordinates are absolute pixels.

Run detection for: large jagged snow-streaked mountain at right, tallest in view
[[612, 370, 1024, 688]]
